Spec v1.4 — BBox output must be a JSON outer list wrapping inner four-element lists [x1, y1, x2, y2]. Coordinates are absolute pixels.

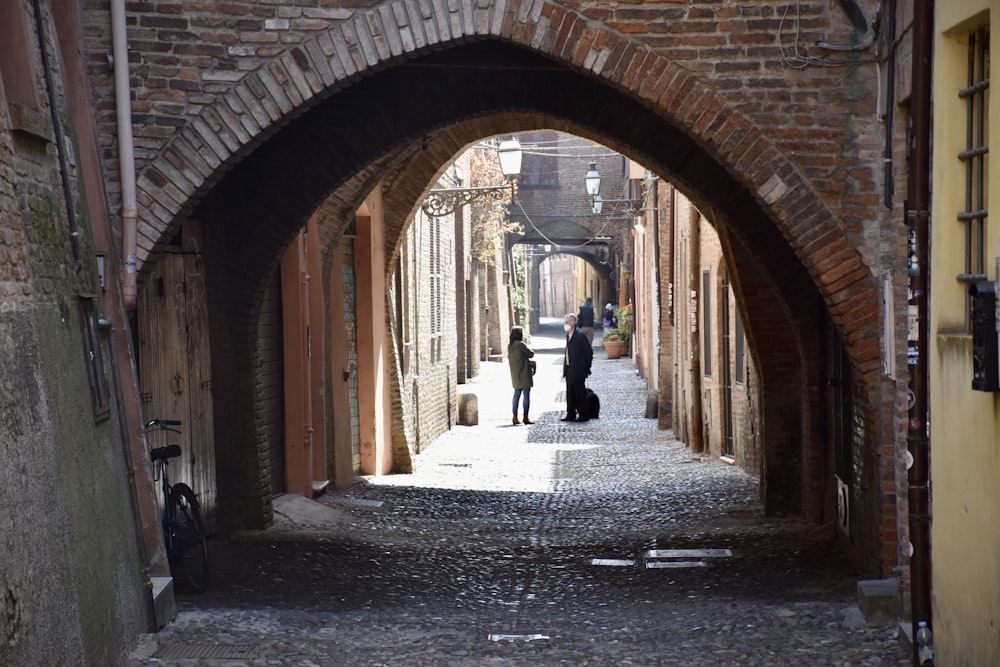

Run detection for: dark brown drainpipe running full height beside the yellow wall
[[906, 0, 934, 665]]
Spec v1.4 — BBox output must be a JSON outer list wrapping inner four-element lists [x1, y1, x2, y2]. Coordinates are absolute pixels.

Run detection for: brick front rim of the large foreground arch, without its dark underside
[[131, 7, 879, 374]]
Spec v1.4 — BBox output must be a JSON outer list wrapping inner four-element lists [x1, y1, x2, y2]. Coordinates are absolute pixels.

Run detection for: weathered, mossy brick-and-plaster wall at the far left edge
[[0, 3, 151, 665]]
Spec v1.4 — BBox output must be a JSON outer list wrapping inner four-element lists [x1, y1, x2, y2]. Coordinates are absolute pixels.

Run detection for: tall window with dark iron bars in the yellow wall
[[957, 26, 990, 329]]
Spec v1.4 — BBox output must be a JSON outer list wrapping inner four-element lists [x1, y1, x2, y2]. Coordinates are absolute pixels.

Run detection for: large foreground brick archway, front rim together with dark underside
[[123, 4, 879, 568]]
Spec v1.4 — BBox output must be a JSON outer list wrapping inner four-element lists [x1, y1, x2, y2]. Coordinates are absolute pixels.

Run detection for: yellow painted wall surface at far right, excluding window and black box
[[929, 0, 1000, 665]]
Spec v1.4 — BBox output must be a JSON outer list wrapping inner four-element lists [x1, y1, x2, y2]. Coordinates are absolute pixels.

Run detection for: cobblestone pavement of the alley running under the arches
[[131, 320, 910, 667]]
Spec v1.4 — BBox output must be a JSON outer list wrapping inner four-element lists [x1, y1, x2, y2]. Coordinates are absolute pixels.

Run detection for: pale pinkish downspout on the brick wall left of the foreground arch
[[111, 0, 137, 311]]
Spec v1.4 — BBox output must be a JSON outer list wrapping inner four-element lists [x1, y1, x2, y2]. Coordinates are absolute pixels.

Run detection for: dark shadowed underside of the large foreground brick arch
[[192, 40, 878, 378]]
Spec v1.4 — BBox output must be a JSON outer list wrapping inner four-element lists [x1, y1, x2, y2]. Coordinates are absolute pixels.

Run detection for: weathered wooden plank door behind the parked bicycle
[[138, 253, 217, 530]]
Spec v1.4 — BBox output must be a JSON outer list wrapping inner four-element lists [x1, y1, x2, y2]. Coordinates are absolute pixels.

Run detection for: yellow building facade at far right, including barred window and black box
[[928, 1, 1000, 665]]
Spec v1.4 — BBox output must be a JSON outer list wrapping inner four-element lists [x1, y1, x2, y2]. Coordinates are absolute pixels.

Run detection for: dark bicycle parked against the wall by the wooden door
[[145, 419, 209, 593]]
